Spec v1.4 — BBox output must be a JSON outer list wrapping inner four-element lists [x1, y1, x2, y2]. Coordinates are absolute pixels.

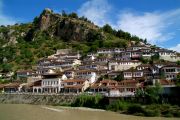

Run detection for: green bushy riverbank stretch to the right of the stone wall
[[71, 94, 180, 117]]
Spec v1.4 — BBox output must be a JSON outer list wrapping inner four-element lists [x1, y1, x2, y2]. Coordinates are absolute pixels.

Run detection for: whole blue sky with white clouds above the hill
[[0, 0, 180, 52]]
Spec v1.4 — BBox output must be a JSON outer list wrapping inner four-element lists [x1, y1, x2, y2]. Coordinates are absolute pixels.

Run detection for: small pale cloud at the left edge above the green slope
[[0, 1, 17, 25]]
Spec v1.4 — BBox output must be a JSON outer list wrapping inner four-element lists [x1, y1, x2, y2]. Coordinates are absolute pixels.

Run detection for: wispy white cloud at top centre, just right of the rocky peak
[[78, 0, 111, 26]]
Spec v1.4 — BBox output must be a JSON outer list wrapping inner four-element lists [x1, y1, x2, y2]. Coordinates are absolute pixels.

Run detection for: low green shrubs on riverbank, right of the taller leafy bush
[[107, 100, 180, 117]]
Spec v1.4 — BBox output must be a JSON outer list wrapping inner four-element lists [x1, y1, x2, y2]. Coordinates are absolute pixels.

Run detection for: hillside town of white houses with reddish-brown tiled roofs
[[0, 44, 180, 97]]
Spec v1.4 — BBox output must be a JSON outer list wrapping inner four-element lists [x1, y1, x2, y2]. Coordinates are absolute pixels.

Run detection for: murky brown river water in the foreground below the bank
[[0, 104, 179, 120]]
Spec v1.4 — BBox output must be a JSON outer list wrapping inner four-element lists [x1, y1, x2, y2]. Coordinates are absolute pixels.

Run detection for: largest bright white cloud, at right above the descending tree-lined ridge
[[117, 9, 180, 44]]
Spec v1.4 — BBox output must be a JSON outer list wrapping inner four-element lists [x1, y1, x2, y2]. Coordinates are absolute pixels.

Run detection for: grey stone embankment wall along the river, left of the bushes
[[0, 94, 77, 105]]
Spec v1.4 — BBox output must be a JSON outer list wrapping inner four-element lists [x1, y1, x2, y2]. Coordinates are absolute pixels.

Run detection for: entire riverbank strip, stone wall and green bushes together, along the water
[[0, 94, 180, 117]]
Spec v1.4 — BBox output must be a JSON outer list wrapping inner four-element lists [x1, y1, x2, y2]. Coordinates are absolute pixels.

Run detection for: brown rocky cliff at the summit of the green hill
[[27, 9, 103, 41]]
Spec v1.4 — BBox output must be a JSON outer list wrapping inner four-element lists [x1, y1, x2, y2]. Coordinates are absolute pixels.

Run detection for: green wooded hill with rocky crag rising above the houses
[[0, 9, 146, 72]]
